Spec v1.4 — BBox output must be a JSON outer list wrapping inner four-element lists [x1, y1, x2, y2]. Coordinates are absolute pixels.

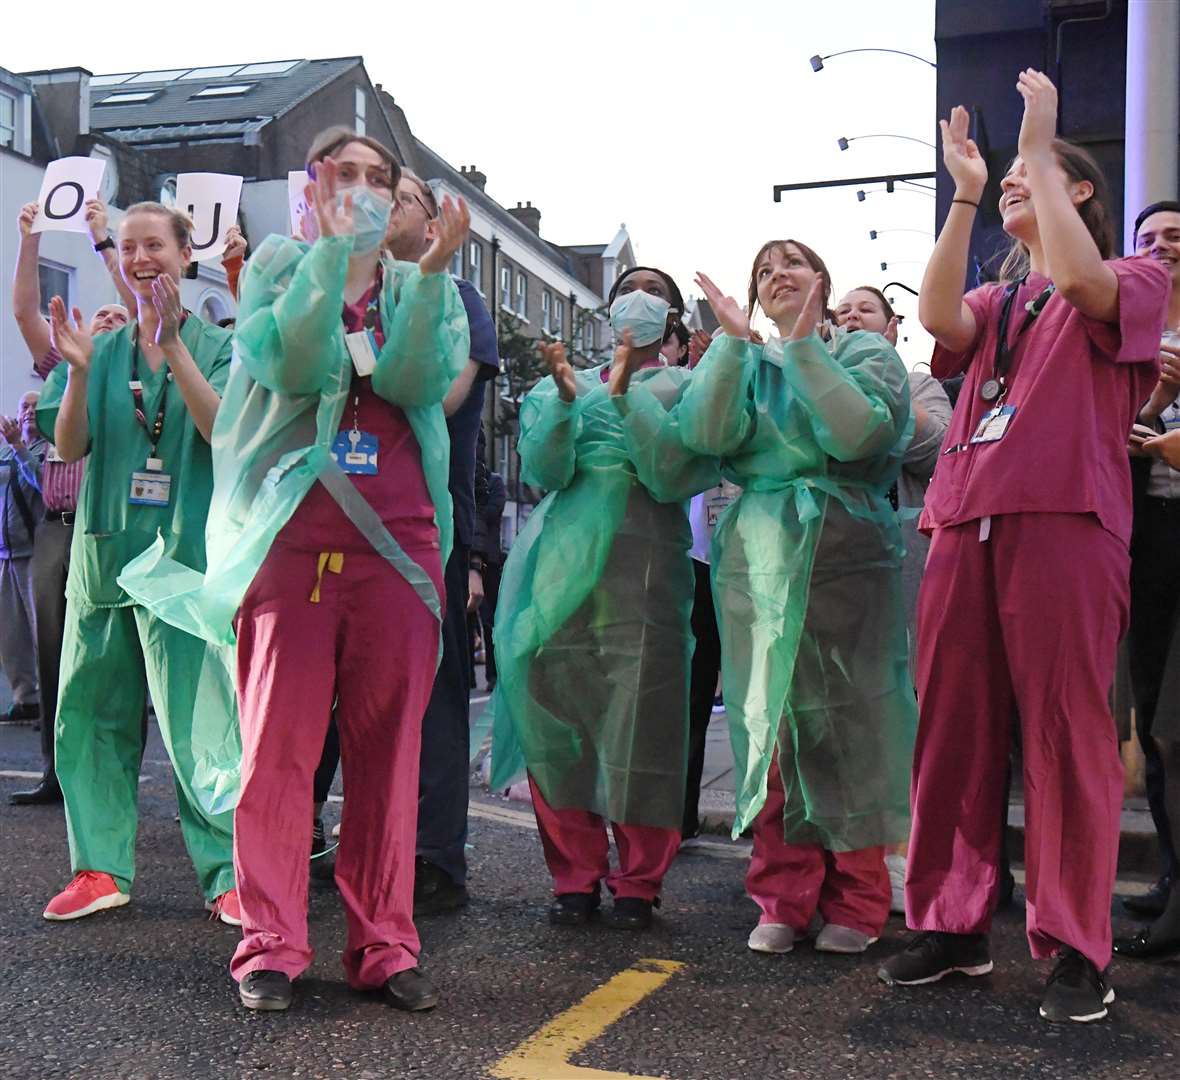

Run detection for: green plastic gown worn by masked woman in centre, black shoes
[[491, 367, 720, 829]]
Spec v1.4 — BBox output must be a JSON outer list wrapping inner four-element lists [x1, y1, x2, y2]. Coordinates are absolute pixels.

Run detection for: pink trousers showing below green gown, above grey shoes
[[746, 757, 891, 937]]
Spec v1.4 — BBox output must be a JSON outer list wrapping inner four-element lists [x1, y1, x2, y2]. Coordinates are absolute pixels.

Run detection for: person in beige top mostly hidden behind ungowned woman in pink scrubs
[[833, 284, 951, 915]]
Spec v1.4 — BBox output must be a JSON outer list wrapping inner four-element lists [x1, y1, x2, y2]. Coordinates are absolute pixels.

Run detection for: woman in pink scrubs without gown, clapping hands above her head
[[879, 70, 1168, 1021]]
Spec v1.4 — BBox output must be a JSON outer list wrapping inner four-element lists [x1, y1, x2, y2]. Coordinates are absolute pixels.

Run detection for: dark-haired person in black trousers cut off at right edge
[[1114, 201, 1180, 960]]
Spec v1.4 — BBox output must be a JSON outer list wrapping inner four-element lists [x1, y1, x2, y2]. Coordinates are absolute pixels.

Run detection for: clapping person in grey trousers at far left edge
[[0, 391, 47, 722]]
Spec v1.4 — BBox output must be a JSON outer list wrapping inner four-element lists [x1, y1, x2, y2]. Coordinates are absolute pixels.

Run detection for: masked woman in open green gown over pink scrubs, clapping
[[123, 127, 470, 1010]]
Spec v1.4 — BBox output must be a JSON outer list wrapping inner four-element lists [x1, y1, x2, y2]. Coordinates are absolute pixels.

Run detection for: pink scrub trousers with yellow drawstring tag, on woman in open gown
[[230, 534, 443, 989]]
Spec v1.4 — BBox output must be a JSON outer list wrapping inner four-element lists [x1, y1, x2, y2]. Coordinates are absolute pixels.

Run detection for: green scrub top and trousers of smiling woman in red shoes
[[37, 315, 241, 899]]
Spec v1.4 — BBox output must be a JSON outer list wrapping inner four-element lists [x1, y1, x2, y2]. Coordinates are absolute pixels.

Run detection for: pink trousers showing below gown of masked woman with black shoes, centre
[[529, 775, 680, 901]]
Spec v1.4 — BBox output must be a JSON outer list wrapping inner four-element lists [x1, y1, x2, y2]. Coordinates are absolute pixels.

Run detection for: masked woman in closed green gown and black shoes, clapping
[[492, 267, 720, 929]]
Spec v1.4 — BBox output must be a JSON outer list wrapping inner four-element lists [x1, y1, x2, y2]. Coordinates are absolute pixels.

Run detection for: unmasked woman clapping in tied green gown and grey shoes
[[681, 240, 917, 953]]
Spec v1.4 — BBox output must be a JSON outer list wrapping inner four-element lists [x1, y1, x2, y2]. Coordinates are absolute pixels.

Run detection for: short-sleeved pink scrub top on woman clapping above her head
[[919, 256, 1171, 543]]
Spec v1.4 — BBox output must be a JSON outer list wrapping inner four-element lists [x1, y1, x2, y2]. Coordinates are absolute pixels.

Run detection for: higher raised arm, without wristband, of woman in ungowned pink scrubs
[[1016, 67, 1119, 322]]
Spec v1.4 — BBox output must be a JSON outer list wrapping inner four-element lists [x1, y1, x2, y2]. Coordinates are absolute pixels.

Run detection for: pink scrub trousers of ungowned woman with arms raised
[[905, 513, 1129, 971]]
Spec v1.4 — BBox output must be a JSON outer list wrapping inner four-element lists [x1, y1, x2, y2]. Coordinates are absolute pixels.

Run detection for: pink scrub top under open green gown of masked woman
[[277, 280, 439, 552]]
